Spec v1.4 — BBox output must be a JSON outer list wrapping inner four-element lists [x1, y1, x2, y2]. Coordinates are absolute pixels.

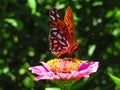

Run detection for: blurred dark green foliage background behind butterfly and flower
[[0, 0, 120, 90]]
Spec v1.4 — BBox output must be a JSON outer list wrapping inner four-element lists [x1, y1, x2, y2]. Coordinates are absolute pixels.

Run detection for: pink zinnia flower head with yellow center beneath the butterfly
[[29, 58, 99, 81]]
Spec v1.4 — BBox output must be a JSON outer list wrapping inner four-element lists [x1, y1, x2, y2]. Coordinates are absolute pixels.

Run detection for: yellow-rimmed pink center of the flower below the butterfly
[[47, 58, 81, 73]]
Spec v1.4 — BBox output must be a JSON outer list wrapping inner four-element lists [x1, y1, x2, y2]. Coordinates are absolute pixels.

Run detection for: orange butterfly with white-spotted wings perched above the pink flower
[[49, 7, 78, 57]]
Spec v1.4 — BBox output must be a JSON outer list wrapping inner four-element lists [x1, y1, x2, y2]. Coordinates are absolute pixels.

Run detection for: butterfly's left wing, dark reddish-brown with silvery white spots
[[49, 7, 70, 56]]
